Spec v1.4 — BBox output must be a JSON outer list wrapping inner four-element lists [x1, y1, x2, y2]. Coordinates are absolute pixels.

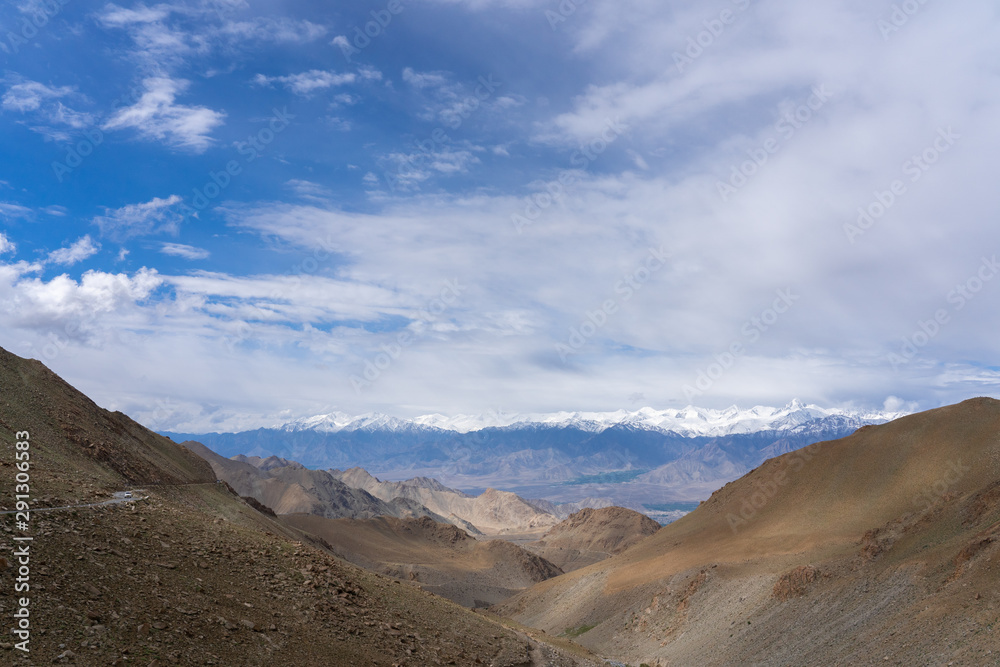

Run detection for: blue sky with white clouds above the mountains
[[0, 0, 1000, 432]]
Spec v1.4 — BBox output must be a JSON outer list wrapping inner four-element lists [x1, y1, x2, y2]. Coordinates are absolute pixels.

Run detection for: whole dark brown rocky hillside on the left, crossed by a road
[[0, 350, 592, 667]]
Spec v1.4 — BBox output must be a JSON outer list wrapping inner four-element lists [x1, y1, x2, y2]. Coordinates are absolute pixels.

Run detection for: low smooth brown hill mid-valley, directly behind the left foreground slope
[[285, 514, 562, 607]]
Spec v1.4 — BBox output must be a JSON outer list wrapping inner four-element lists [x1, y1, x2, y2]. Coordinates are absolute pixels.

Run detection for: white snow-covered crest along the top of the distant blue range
[[272, 399, 907, 437]]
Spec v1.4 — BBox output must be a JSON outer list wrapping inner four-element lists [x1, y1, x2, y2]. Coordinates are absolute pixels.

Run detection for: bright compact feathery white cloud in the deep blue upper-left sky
[[103, 77, 226, 153]]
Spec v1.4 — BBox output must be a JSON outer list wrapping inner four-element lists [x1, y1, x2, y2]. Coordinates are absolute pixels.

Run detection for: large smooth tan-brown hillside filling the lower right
[[498, 398, 1000, 665]]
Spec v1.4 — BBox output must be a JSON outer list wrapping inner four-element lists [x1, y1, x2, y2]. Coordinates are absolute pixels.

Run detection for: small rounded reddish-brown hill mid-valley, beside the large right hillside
[[524, 507, 660, 572]]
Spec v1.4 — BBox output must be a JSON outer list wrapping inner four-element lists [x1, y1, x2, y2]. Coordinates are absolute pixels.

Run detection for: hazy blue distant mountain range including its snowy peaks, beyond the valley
[[165, 401, 901, 519]]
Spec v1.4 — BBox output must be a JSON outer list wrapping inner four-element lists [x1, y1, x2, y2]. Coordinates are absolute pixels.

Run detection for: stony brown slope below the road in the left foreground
[[0, 484, 591, 667]]
